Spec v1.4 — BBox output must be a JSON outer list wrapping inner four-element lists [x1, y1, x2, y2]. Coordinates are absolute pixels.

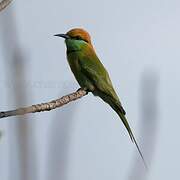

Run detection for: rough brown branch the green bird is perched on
[[0, 89, 87, 118]]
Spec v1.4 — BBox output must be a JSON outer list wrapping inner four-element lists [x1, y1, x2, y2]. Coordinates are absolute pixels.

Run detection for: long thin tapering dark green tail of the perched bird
[[109, 103, 148, 169]]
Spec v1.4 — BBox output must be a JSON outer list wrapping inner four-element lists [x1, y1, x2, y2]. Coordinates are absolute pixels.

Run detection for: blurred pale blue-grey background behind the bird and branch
[[0, 0, 180, 180]]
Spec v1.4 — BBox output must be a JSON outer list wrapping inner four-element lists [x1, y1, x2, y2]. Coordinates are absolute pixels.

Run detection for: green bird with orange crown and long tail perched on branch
[[54, 28, 147, 168]]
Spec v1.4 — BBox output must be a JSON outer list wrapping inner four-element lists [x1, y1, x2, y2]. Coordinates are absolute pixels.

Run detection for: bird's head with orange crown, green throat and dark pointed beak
[[55, 28, 92, 51]]
